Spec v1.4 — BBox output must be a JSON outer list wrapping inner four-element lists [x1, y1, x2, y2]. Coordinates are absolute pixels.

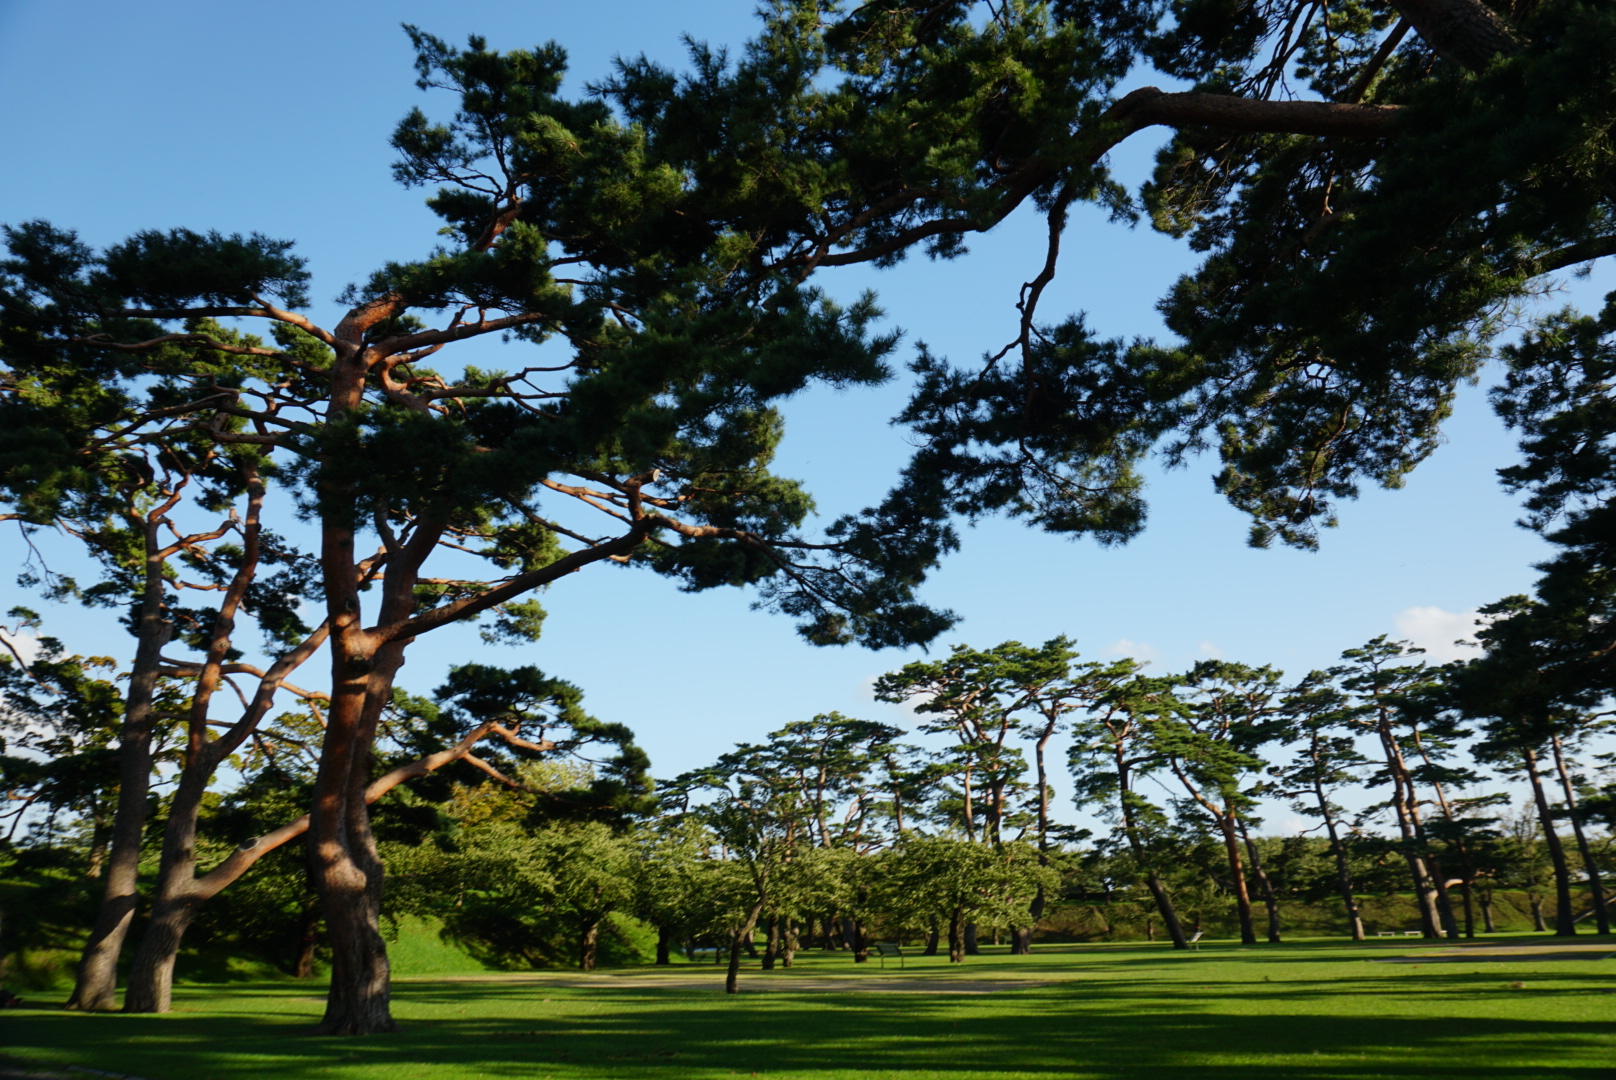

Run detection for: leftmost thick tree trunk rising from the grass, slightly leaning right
[[68, 540, 175, 1012]]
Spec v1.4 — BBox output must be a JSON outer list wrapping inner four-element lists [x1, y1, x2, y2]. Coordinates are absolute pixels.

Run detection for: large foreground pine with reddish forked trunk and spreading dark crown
[[0, 31, 949, 1033]]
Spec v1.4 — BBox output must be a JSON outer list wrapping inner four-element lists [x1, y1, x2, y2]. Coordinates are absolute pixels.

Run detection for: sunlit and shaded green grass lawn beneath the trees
[[0, 936, 1616, 1080]]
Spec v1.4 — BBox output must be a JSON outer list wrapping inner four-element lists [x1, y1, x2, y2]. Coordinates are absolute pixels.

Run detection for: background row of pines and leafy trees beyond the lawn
[[0, 620, 1616, 1006]]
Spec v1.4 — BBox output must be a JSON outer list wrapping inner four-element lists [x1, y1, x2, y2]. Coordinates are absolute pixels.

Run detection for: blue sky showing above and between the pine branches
[[0, 0, 1601, 827]]
